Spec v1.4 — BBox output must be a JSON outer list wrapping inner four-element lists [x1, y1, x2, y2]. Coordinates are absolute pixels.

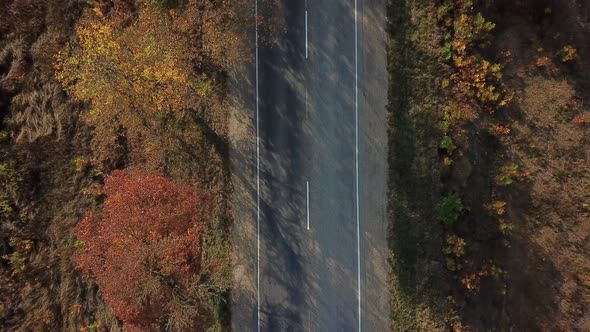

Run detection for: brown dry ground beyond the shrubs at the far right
[[484, 0, 590, 331]]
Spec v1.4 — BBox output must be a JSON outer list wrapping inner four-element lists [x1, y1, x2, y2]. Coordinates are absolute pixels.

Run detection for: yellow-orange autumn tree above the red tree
[[56, 0, 250, 166]]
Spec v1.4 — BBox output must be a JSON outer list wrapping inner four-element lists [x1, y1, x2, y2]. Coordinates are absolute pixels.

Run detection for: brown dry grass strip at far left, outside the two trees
[[0, 0, 125, 331]]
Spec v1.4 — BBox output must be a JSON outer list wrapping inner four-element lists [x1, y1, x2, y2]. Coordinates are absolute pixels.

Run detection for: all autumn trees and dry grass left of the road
[[0, 0, 273, 331]]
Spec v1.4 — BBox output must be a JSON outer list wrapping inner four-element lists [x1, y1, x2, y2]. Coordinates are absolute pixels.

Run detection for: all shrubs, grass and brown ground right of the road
[[389, 0, 590, 331]]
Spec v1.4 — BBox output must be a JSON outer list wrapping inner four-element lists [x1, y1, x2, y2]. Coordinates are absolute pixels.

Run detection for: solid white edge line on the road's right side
[[354, 0, 362, 332]]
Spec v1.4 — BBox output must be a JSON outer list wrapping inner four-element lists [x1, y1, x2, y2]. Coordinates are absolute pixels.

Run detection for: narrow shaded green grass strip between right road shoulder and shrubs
[[388, 0, 450, 331]]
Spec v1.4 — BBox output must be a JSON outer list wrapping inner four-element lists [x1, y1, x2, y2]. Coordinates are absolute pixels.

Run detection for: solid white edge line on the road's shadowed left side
[[254, 0, 260, 332]]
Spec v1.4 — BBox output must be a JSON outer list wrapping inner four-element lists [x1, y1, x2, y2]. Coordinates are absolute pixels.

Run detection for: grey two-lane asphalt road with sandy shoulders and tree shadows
[[230, 0, 389, 331]]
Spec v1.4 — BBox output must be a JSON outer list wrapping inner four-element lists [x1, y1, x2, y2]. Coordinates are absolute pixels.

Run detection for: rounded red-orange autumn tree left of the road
[[75, 170, 223, 331]]
